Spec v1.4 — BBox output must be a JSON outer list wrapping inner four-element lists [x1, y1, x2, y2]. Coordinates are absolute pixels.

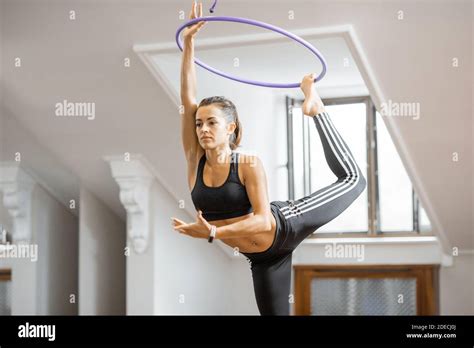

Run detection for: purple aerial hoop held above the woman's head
[[176, 0, 327, 88]]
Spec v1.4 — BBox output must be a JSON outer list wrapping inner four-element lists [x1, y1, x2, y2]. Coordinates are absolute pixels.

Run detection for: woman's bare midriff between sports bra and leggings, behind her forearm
[[209, 209, 276, 253]]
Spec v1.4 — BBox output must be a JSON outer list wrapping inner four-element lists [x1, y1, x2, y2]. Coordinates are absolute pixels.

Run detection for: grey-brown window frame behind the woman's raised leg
[[286, 96, 433, 238]]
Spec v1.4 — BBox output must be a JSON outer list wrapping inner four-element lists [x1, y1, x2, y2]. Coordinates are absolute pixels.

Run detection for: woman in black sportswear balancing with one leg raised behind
[[173, 3, 366, 315]]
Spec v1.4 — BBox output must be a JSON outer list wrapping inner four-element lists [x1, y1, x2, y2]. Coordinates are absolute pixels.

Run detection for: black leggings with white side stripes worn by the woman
[[242, 112, 366, 315]]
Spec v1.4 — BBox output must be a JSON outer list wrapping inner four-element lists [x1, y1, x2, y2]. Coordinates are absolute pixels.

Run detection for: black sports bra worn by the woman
[[191, 152, 253, 221]]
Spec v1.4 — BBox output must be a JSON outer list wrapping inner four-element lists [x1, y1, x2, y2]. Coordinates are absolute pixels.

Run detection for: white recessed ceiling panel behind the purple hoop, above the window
[[153, 35, 368, 97]]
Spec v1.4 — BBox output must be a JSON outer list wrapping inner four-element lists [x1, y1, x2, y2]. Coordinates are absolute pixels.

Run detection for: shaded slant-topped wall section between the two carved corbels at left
[[79, 188, 126, 315]]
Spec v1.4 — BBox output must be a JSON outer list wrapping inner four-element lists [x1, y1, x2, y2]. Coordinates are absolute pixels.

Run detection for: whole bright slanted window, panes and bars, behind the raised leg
[[287, 97, 430, 234]]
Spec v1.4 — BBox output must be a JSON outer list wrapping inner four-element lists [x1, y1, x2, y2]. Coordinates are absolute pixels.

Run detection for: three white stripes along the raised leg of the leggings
[[282, 112, 360, 219]]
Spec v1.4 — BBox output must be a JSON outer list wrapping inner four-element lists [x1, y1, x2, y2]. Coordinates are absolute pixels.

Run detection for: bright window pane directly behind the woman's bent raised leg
[[293, 103, 368, 233]]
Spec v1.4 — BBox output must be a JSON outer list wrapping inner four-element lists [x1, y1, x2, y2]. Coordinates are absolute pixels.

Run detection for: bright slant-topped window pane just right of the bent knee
[[376, 112, 413, 232]]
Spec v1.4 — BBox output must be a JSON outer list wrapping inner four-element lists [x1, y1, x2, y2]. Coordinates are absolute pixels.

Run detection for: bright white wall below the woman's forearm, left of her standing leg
[[151, 184, 239, 315]]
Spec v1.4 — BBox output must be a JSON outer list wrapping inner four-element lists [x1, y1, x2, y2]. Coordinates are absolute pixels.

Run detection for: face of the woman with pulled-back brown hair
[[196, 104, 235, 150]]
